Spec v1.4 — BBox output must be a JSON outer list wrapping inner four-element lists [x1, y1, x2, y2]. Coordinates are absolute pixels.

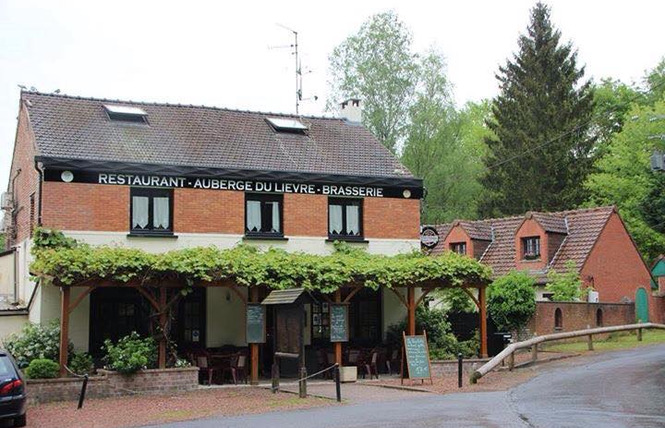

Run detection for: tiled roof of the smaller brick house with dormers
[[431, 207, 614, 277]]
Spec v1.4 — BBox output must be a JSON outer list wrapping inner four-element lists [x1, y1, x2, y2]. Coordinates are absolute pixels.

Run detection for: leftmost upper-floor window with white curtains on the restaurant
[[130, 187, 173, 234]]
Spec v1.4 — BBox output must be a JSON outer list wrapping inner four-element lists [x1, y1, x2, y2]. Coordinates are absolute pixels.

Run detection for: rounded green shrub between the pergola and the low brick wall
[[487, 271, 536, 331]]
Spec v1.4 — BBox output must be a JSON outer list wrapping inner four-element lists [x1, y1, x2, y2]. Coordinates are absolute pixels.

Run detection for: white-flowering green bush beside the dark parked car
[[3, 320, 74, 369]]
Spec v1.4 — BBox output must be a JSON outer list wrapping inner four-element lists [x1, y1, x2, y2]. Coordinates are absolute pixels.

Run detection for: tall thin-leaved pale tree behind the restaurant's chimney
[[328, 12, 418, 152]]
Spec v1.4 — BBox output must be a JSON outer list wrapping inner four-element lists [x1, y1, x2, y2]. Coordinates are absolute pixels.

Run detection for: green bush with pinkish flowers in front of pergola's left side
[[104, 331, 157, 373]]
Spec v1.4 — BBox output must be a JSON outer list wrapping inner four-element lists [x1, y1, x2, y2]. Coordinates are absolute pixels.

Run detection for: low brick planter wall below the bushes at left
[[27, 367, 199, 404]]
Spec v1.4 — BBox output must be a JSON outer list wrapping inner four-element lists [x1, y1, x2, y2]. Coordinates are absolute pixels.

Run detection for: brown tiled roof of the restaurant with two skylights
[[21, 92, 412, 178]]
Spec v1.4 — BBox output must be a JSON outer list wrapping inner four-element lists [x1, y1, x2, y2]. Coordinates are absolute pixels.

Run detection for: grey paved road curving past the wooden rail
[[153, 345, 665, 428]]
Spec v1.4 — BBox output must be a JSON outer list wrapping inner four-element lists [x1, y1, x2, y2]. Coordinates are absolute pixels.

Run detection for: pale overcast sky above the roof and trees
[[0, 0, 665, 188]]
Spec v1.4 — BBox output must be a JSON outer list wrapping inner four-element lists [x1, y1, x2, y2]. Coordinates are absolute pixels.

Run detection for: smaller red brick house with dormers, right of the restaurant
[[431, 206, 665, 321]]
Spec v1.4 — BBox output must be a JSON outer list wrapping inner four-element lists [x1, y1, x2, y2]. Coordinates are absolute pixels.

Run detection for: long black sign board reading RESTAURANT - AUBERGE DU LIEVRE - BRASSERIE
[[44, 169, 423, 199]]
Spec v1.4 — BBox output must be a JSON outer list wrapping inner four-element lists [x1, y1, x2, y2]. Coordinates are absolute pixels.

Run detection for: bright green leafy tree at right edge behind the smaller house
[[586, 101, 665, 260]]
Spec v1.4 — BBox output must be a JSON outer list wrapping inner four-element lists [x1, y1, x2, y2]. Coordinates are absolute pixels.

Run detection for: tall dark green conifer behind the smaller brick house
[[480, 3, 594, 216]]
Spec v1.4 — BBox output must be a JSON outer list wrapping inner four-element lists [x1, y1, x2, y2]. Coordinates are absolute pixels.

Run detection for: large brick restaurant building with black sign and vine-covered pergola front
[[4, 92, 423, 352]]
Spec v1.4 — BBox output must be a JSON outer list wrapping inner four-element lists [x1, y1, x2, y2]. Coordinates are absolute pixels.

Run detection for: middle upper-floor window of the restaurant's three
[[245, 193, 284, 236]]
